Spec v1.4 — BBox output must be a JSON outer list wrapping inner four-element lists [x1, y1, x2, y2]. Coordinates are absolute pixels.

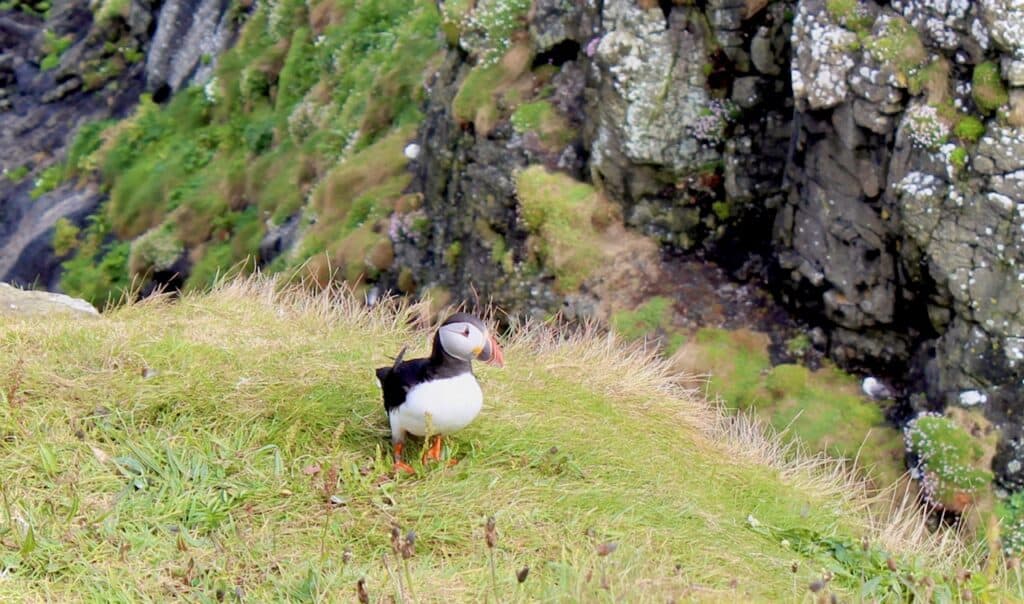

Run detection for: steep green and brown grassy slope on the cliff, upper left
[[56, 0, 443, 304]]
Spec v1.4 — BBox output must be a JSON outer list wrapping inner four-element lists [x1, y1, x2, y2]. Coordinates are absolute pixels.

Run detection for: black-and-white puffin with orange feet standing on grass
[[376, 312, 505, 474]]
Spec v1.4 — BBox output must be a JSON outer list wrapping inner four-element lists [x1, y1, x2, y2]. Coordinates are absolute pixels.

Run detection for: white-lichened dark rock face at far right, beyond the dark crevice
[[774, 0, 1024, 487]]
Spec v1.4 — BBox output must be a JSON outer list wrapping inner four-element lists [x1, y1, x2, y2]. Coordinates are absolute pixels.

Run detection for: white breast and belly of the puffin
[[390, 372, 483, 436]]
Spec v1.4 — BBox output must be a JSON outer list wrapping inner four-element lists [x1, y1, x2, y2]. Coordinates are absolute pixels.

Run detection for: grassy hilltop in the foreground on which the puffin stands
[[0, 279, 1016, 602]]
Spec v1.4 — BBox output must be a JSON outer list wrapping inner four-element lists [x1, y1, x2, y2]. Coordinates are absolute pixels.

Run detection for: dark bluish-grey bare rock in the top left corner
[[0, 1, 145, 288]]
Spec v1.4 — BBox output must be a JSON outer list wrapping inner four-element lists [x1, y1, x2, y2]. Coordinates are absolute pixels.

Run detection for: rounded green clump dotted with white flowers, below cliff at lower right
[[903, 414, 992, 512]]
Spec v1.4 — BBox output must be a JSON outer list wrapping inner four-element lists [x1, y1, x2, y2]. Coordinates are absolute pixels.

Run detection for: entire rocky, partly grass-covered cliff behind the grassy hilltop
[[0, 0, 1024, 488]]
